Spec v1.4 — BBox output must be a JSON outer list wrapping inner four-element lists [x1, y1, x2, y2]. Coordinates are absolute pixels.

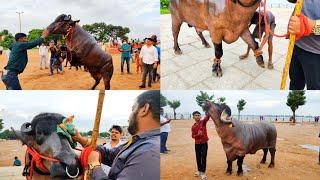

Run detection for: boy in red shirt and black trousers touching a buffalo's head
[[191, 111, 209, 180]]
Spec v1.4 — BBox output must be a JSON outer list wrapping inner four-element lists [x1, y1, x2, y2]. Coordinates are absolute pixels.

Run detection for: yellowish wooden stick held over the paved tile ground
[[280, 0, 303, 90]]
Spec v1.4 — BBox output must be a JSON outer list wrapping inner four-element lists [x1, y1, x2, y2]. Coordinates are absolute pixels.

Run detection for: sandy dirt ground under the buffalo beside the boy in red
[[161, 120, 320, 180]]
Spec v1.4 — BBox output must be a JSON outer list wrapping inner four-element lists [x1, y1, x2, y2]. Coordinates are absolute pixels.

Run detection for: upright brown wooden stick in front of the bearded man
[[91, 90, 105, 149]]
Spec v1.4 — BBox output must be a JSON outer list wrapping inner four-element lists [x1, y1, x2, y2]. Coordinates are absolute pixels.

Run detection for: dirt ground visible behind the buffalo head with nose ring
[[0, 138, 105, 167]]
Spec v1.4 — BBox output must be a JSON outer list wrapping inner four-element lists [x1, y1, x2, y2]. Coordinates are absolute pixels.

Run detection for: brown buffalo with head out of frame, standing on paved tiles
[[170, 0, 264, 76]]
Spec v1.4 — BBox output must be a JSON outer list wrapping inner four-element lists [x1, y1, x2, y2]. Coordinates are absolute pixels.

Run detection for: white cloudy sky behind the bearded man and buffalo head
[[0, 91, 143, 131]]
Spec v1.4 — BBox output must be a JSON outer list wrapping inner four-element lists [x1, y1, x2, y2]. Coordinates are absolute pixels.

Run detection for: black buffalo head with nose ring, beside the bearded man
[[13, 113, 80, 179]]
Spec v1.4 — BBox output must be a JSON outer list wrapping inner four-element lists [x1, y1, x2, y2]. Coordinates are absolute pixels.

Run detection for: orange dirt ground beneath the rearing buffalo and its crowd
[[0, 49, 160, 90]]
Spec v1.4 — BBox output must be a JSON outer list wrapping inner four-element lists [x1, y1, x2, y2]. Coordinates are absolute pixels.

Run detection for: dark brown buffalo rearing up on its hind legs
[[47, 14, 113, 89]]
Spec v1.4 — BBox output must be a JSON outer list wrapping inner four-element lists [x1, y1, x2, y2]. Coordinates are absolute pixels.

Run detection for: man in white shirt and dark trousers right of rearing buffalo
[[139, 38, 158, 88]]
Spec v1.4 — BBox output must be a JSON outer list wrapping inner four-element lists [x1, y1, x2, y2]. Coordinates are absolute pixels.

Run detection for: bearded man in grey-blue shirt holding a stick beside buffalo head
[[73, 90, 160, 180]]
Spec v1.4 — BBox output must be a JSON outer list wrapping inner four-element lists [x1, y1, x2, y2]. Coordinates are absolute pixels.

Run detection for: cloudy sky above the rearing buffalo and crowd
[[0, 0, 160, 38]]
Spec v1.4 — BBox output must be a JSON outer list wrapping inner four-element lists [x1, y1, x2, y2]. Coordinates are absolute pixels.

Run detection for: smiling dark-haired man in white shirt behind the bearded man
[[101, 125, 123, 174]]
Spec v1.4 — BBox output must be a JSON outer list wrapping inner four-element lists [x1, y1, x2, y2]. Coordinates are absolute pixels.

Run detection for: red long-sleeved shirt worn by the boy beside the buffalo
[[191, 116, 209, 144]]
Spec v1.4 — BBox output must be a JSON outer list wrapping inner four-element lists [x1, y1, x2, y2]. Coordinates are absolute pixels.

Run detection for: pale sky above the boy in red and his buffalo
[[161, 91, 320, 116]]
